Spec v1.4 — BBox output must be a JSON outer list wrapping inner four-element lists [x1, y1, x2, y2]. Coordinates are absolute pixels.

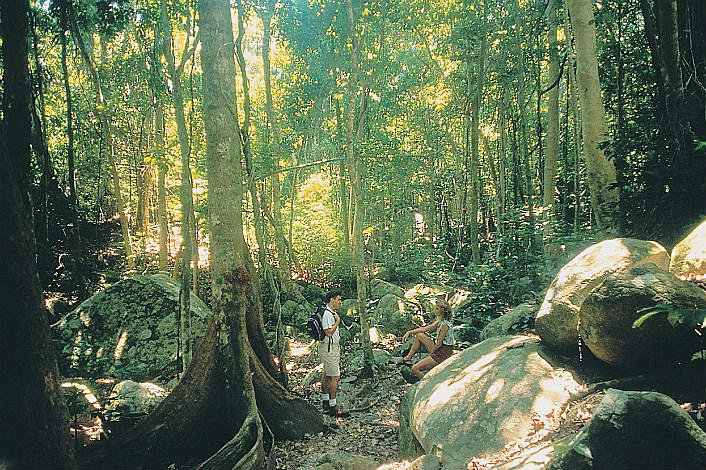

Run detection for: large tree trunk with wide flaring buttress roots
[[81, 0, 323, 470]]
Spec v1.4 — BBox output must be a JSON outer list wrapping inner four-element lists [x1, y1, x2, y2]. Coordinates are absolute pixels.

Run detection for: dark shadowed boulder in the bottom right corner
[[549, 389, 706, 470]]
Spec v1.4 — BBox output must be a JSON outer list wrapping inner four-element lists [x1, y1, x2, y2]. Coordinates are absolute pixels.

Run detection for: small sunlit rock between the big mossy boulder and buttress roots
[[104, 380, 167, 421]]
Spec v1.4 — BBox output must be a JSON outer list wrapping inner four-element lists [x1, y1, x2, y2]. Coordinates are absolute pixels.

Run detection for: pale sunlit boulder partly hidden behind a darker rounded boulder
[[535, 238, 669, 351]]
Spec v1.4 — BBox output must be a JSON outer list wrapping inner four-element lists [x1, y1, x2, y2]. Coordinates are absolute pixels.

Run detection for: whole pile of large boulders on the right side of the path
[[399, 218, 706, 470]]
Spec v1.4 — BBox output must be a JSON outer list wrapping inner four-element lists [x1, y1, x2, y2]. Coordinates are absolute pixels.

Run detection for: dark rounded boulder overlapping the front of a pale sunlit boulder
[[579, 263, 706, 368]]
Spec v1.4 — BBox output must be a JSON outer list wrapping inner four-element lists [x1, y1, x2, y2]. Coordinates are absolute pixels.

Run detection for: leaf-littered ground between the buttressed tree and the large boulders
[[275, 340, 410, 470]]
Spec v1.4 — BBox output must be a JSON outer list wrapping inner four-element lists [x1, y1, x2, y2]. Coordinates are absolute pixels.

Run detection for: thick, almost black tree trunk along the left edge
[[0, 0, 75, 469]]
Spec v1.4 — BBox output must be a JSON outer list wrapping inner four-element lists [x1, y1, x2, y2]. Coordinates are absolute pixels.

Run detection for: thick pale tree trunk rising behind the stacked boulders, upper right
[[568, 0, 620, 233]]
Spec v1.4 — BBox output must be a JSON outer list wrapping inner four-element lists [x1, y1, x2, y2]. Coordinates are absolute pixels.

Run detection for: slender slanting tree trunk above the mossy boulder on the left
[[69, 7, 135, 270]]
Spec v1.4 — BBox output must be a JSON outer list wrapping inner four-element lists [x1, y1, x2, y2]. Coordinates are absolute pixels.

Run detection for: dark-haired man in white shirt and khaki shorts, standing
[[319, 290, 348, 417]]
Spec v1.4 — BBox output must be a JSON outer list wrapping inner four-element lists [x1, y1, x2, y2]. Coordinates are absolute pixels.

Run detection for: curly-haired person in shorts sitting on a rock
[[402, 300, 456, 379]]
